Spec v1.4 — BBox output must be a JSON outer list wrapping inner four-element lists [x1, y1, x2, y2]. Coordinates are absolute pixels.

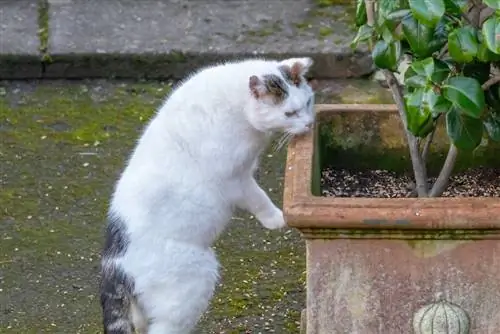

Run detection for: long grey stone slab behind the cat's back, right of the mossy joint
[[44, 0, 372, 78]]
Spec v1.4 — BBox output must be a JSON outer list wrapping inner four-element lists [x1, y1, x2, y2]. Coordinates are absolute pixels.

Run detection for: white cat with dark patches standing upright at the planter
[[100, 58, 315, 334]]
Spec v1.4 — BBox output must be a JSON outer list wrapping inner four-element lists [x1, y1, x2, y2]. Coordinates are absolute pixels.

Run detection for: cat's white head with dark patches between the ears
[[248, 57, 315, 135]]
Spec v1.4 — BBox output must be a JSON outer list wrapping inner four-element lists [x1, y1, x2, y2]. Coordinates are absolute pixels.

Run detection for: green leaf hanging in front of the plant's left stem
[[405, 89, 433, 138]]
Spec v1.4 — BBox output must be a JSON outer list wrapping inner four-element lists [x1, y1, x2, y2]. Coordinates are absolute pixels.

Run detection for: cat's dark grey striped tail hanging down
[[100, 264, 134, 334]]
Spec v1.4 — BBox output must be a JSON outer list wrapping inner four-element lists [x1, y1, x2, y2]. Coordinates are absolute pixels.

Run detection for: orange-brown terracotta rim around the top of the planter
[[283, 104, 500, 231]]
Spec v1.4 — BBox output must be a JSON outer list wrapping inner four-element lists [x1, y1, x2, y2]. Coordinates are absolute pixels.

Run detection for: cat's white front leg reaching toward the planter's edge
[[237, 176, 286, 230]]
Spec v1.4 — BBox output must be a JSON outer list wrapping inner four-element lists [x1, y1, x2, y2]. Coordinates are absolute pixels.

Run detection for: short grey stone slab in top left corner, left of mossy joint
[[0, 0, 42, 79]]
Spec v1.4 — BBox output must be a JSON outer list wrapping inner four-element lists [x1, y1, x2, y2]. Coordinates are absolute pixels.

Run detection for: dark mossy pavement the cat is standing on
[[0, 81, 385, 334]]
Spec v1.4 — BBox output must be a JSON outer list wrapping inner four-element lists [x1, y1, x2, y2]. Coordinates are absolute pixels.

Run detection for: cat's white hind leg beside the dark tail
[[133, 242, 219, 334]]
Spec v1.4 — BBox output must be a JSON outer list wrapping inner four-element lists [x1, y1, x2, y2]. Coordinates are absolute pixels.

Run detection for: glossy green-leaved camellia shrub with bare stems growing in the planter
[[351, 0, 500, 197]]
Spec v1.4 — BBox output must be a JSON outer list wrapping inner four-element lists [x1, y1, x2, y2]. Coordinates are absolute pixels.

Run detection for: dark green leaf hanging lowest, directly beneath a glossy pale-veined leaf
[[446, 109, 483, 151]]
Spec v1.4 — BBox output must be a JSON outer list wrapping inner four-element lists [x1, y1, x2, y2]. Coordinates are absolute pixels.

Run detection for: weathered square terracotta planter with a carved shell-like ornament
[[283, 105, 500, 334]]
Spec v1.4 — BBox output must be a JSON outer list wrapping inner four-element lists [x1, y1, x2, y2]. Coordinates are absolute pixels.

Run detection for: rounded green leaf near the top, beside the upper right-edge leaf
[[448, 26, 479, 63]]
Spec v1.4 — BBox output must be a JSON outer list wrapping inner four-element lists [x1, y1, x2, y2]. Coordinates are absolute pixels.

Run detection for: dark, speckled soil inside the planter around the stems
[[321, 168, 500, 198]]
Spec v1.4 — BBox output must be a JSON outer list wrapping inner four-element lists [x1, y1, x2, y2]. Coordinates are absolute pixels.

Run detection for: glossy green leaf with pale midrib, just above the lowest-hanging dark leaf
[[442, 76, 485, 118]]
